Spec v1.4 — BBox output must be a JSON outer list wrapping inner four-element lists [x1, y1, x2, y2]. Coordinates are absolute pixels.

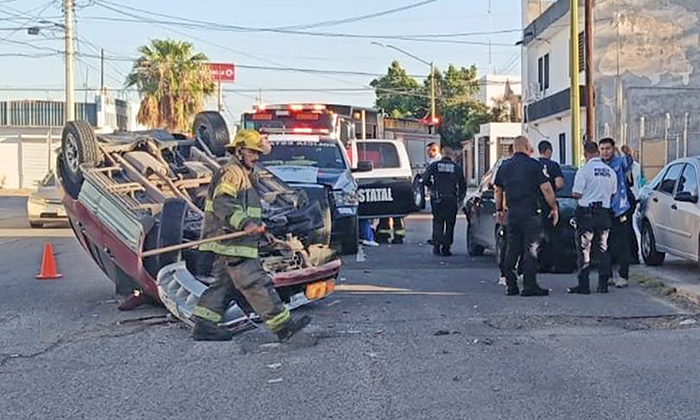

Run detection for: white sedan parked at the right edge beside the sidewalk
[[636, 156, 700, 265]]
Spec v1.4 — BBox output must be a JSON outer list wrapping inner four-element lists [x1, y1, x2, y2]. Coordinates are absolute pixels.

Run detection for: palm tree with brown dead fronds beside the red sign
[[126, 39, 215, 132]]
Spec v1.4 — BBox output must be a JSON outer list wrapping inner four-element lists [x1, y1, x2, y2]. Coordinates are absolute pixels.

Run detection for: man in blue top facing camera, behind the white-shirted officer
[[599, 137, 632, 287]]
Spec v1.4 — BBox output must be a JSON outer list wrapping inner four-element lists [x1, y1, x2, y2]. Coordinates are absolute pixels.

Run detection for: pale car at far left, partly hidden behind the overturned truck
[[27, 172, 68, 228]]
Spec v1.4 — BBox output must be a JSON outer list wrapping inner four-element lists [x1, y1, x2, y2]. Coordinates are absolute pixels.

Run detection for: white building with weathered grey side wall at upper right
[[522, 0, 700, 175]]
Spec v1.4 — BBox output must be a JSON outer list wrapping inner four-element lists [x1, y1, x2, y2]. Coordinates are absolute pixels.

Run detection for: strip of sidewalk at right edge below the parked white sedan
[[630, 255, 700, 304]]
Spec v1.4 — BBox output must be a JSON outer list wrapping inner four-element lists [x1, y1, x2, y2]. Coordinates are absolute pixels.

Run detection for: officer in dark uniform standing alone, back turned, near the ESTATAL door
[[425, 147, 467, 257]]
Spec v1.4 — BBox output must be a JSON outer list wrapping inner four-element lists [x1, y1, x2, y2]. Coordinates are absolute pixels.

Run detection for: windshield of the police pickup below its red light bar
[[260, 141, 346, 169]]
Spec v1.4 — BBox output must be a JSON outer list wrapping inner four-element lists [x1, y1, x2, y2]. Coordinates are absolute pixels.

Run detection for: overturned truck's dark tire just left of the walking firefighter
[[143, 198, 187, 278]]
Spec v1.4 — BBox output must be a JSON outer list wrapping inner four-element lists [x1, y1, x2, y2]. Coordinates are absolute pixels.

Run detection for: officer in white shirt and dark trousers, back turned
[[567, 142, 617, 295]]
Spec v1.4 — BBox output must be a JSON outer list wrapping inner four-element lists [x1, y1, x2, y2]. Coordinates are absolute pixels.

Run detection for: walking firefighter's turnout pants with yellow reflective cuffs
[[194, 255, 291, 332]]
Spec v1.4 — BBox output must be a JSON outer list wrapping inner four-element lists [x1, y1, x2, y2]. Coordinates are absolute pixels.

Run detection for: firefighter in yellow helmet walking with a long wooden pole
[[192, 130, 316, 347]]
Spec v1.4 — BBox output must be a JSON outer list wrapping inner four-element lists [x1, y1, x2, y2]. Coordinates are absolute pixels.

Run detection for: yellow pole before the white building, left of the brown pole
[[569, 0, 581, 166]]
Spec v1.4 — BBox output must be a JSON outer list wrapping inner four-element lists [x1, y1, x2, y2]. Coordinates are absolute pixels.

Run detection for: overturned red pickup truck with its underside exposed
[[57, 112, 341, 328]]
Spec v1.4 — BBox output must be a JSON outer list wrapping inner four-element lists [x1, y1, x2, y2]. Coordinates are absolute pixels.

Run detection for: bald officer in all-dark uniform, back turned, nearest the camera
[[495, 136, 559, 296]]
